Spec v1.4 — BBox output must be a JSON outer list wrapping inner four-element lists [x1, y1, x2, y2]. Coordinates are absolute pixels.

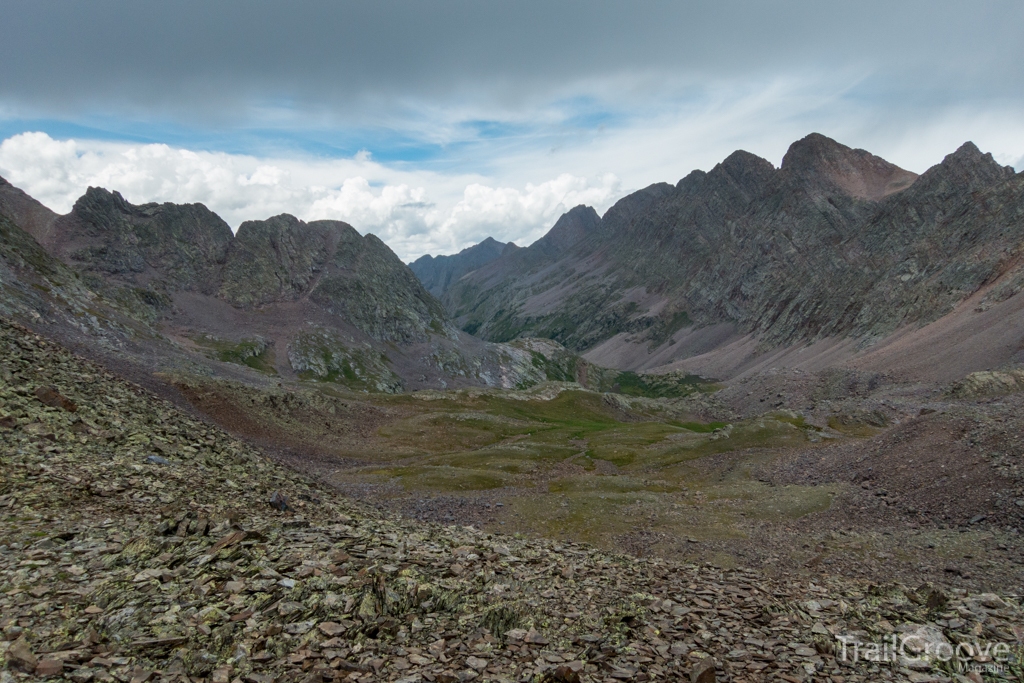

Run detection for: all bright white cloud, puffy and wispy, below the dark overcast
[[0, 72, 1024, 260]]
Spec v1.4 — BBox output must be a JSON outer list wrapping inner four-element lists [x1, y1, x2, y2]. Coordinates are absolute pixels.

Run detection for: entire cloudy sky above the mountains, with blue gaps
[[0, 0, 1024, 261]]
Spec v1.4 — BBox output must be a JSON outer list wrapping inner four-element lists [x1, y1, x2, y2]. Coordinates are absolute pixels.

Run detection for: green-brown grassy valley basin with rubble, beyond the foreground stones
[[167, 366, 1024, 591]]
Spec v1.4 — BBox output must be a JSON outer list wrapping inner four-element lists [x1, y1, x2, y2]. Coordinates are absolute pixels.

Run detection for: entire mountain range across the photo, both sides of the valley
[[0, 134, 1024, 392]]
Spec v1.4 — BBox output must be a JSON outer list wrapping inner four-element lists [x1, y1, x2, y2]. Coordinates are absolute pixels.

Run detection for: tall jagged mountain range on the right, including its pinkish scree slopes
[[432, 134, 1024, 380]]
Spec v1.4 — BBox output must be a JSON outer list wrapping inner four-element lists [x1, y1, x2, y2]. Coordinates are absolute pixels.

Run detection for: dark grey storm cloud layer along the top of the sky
[[0, 0, 1024, 117]]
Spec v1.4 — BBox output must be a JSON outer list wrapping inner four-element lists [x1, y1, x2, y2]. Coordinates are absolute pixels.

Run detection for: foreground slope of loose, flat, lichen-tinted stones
[[0, 321, 1024, 683]]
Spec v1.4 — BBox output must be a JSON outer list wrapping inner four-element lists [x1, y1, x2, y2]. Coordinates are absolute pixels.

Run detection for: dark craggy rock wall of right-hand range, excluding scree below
[[444, 134, 1024, 358]]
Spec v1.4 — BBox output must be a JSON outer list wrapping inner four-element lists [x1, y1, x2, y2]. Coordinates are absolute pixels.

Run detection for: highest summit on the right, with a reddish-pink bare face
[[781, 133, 918, 202]]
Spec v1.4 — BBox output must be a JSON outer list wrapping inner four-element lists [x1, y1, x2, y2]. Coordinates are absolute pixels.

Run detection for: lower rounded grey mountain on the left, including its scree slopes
[[0, 179, 589, 392]]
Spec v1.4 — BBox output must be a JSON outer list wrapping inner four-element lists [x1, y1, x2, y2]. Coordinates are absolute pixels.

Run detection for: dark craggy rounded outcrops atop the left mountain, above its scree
[[34, 187, 446, 342]]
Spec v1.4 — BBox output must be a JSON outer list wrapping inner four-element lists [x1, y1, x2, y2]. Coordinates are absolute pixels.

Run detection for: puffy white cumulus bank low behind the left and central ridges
[[0, 132, 620, 259]]
